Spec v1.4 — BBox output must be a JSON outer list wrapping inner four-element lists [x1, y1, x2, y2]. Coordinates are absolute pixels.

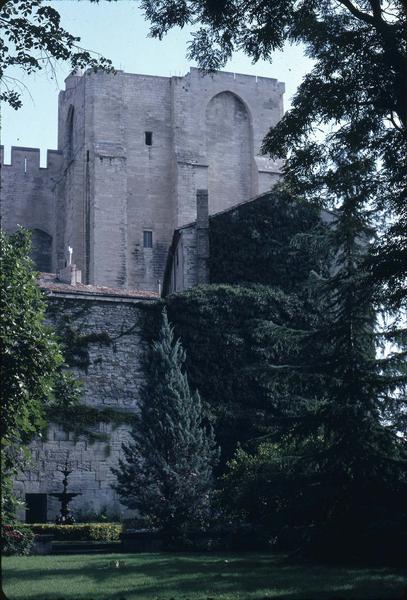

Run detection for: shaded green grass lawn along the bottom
[[3, 554, 407, 600]]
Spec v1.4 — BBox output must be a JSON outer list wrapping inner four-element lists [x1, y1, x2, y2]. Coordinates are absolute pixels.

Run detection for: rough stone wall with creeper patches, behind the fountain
[[16, 295, 150, 520]]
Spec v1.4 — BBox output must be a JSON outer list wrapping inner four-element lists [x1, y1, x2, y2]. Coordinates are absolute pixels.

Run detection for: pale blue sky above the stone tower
[[1, 0, 311, 166]]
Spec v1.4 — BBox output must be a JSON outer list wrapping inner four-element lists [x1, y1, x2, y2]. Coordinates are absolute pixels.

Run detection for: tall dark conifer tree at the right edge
[[278, 154, 407, 549]]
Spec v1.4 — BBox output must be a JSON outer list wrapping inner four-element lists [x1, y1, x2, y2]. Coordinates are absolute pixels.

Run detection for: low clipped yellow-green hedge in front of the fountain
[[30, 523, 122, 542]]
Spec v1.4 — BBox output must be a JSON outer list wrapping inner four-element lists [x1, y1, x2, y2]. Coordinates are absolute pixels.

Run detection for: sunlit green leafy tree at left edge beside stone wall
[[0, 229, 77, 510]]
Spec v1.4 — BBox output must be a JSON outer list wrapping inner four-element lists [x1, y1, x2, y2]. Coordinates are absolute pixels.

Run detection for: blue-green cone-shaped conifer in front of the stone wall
[[114, 311, 218, 539]]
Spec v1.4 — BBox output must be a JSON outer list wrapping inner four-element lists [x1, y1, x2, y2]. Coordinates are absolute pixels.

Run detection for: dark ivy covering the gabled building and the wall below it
[[151, 195, 329, 463]]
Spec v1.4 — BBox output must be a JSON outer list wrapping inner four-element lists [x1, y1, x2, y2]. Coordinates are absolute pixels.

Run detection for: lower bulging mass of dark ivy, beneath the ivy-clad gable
[[145, 285, 326, 463]]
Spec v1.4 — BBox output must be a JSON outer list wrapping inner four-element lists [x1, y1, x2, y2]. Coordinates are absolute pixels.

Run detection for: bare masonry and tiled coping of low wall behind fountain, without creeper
[[15, 280, 159, 520]]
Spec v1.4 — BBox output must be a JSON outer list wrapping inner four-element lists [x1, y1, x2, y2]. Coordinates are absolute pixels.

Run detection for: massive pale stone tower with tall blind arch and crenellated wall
[[2, 69, 284, 291]]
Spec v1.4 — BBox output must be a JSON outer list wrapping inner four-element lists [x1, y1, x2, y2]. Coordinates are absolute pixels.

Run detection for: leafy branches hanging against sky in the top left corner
[[0, 0, 112, 109]]
